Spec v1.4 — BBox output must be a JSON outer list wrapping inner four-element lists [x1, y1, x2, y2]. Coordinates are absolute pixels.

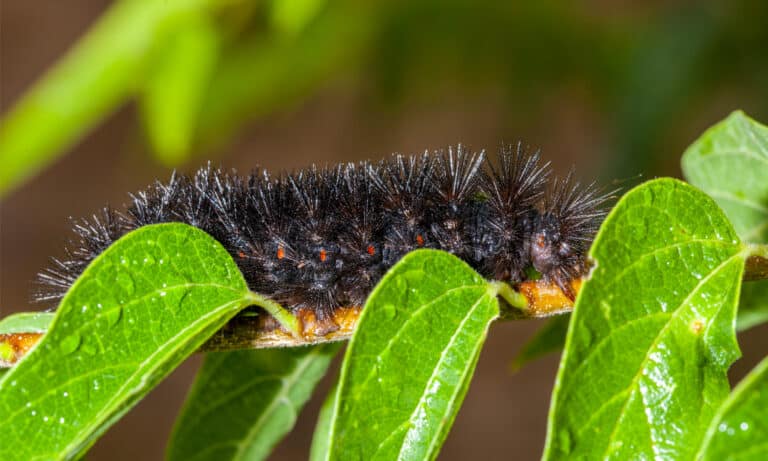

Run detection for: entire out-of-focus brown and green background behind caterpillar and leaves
[[0, 0, 768, 460]]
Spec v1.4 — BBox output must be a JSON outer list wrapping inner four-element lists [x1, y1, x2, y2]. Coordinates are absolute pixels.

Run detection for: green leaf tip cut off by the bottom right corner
[[696, 357, 768, 461]]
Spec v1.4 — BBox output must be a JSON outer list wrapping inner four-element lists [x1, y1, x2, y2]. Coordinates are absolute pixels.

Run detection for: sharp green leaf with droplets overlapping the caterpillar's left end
[[0, 224, 258, 459]]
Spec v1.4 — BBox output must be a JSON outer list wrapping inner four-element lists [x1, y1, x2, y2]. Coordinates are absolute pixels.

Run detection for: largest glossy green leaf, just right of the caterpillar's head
[[544, 179, 745, 460]]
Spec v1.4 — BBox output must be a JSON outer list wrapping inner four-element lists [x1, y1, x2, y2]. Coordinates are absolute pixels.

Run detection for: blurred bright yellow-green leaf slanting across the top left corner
[[0, 0, 216, 196]]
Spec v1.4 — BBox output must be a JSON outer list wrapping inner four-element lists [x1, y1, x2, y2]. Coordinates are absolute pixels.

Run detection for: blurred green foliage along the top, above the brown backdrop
[[0, 0, 768, 195]]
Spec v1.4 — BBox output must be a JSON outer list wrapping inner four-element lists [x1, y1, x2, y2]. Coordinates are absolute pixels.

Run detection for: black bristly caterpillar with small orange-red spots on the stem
[[35, 144, 611, 328]]
